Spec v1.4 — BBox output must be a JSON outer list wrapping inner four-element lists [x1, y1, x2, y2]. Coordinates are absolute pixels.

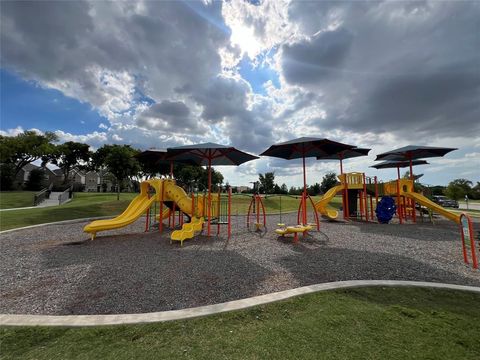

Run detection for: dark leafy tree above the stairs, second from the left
[[51, 141, 91, 184]]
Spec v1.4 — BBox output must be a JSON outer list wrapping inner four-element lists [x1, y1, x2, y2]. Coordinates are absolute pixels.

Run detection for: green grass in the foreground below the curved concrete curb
[[0, 287, 480, 360]]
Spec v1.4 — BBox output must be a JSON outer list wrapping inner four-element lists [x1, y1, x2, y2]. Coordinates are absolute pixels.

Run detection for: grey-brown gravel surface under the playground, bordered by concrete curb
[[0, 214, 480, 315]]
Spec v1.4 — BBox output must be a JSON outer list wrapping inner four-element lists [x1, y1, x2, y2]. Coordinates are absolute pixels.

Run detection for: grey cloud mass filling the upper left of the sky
[[0, 1, 229, 114]]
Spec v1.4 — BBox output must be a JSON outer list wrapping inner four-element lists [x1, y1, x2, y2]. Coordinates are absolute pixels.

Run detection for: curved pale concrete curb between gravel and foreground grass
[[0, 280, 480, 326]]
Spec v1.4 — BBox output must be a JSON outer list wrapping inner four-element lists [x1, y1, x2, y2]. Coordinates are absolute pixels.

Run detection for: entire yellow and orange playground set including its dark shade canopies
[[84, 138, 477, 267]]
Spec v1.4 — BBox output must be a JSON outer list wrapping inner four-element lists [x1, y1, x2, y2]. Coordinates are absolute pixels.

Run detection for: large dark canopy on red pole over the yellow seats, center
[[260, 137, 355, 160]]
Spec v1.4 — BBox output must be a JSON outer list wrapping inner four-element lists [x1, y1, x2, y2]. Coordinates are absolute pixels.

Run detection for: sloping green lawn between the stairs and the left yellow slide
[[0, 193, 138, 230]]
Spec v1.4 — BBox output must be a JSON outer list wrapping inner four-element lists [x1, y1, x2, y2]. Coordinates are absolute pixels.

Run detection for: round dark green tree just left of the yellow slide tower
[[96, 145, 140, 200]]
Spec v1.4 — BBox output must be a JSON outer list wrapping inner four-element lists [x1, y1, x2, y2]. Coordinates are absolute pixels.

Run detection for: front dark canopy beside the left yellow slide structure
[[168, 143, 258, 166]]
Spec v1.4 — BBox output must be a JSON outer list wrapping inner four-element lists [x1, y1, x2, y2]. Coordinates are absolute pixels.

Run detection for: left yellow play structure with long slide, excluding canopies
[[83, 179, 231, 245]]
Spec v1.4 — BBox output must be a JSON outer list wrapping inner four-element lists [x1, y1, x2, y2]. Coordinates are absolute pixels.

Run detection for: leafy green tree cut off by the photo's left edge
[[0, 131, 58, 177]]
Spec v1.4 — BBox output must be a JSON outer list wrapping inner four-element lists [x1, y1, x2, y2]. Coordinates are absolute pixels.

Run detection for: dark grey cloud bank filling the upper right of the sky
[[282, 1, 480, 140]]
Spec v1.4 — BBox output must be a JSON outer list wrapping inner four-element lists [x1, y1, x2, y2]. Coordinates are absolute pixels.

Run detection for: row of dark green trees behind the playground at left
[[0, 131, 223, 197]]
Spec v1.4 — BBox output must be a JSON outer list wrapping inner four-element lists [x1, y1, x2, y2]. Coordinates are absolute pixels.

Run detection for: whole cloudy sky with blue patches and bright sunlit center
[[0, 0, 480, 186]]
